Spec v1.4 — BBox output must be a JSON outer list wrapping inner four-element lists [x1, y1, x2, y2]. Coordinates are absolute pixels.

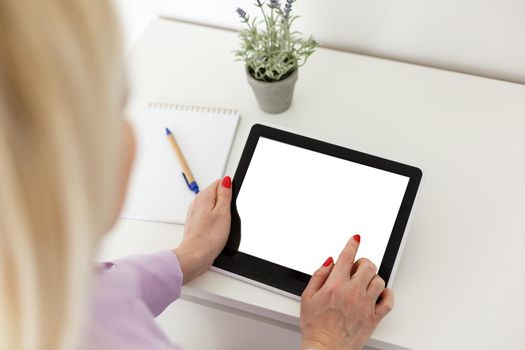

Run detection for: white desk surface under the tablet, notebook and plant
[[97, 20, 525, 349]]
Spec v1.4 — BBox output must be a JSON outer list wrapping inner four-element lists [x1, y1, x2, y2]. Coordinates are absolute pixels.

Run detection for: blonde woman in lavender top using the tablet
[[0, 0, 393, 350]]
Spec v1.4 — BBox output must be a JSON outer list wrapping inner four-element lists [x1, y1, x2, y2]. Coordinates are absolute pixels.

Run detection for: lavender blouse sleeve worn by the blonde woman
[[85, 251, 182, 350]]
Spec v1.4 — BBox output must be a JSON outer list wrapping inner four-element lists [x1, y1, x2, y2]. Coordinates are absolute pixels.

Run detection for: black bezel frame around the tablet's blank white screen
[[213, 124, 423, 296]]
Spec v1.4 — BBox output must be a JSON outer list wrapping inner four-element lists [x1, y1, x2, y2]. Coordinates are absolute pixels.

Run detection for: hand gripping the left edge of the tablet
[[173, 176, 232, 283]]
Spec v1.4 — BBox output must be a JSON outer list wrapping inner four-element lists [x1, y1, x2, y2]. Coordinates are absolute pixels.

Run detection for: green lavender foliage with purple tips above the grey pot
[[235, 0, 317, 82]]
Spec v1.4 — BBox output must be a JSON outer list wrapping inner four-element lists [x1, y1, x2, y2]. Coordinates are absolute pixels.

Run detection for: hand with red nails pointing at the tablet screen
[[300, 235, 394, 350]]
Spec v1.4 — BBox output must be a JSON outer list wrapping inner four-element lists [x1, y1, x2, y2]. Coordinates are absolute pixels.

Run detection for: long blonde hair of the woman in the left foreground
[[0, 0, 124, 350]]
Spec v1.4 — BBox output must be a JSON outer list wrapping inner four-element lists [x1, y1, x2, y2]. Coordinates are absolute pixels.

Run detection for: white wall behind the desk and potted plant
[[152, 0, 525, 82]]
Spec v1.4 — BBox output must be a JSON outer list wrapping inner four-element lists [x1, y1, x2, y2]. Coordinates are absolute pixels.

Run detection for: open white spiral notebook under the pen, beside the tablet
[[121, 103, 239, 224]]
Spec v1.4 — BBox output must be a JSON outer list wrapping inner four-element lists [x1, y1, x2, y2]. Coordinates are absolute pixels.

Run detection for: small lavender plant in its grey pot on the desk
[[235, 0, 317, 113]]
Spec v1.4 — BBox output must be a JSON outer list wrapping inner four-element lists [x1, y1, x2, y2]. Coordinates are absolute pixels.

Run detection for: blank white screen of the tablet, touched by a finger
[[237, 137, 409, 274]]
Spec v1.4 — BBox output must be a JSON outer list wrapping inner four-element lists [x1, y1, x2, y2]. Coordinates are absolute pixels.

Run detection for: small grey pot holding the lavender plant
[[246, 69, 299, 114]]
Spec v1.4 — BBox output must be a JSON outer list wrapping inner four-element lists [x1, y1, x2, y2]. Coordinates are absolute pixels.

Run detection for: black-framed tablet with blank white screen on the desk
[[213, 124, 422, 298]]
